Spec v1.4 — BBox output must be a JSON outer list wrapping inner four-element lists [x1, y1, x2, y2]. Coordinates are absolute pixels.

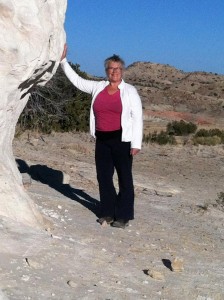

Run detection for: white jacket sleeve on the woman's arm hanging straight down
[[129, 87, 143, 149]]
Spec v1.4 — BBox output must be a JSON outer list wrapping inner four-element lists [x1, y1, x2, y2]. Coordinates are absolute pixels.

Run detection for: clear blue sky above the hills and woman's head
[[65, 0, 224, 76]]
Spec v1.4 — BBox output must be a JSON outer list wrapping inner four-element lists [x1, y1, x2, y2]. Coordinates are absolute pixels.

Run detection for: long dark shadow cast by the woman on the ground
[[16, 159, 99, 216]]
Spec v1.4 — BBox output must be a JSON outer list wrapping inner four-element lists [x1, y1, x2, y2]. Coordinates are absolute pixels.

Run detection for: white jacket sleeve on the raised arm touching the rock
[[61, 58, 98, 94]]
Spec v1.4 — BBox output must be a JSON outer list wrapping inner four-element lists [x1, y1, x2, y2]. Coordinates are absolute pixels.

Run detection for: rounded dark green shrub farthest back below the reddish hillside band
[[166, 120, 197, 136]]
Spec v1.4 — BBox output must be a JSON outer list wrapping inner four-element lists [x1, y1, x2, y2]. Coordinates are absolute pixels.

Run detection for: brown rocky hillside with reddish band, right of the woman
[[125, 62, 224, 130]]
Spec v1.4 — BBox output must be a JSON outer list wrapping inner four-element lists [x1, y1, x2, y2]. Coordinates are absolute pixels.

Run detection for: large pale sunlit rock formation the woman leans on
[[0, 0, 67, 226]]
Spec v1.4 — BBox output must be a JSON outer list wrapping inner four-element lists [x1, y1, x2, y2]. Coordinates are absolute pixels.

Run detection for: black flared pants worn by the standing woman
[[95, 132, 134, 220]]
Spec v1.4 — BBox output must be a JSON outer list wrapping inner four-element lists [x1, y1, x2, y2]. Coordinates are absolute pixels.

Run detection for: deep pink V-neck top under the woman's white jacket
[[93, 87, 122, 131]]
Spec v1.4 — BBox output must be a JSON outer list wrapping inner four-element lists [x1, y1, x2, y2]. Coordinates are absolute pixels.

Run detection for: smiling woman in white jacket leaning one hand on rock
[[61, 45, 143, 228]]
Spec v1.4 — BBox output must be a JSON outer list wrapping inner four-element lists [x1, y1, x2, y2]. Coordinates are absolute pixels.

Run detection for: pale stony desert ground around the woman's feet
[[0, 133, 224, 300]]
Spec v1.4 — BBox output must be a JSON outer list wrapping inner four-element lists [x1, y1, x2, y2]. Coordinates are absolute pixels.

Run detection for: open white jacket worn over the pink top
[[61, 58, 143, 149]]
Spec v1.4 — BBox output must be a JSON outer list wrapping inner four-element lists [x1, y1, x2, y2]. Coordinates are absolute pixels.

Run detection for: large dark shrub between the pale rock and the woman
[[17, 64, 91, 133]]
